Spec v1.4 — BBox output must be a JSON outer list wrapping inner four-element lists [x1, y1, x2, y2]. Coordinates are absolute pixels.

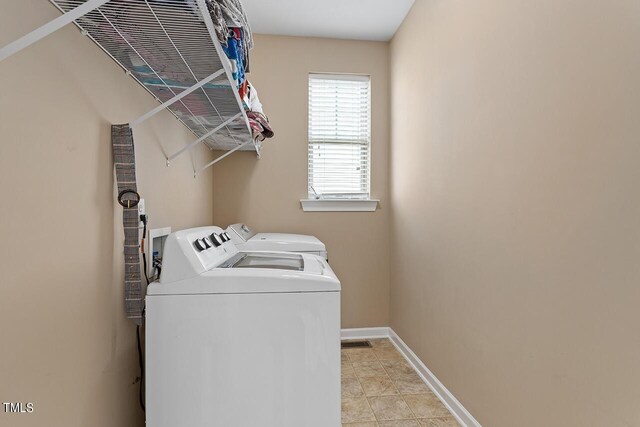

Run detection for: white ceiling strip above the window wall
[[242, 0, 414, 41]]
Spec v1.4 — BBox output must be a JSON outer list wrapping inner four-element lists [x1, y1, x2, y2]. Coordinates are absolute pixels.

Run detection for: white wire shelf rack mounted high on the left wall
[[50, 0, 260, 169]]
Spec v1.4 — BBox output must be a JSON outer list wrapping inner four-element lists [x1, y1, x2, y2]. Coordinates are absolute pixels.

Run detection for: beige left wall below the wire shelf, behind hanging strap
[[0, 0, 213, 427]]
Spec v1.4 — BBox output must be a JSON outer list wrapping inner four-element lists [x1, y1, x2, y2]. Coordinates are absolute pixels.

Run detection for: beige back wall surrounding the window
[[213, 36, 389, 328]]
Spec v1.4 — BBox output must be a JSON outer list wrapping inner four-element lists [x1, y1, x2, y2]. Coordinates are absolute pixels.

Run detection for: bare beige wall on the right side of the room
[[391, 0, 640, 427]]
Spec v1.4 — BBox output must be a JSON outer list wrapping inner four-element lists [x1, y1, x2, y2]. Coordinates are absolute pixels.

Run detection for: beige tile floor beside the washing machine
[[342, 339, 458, 427]]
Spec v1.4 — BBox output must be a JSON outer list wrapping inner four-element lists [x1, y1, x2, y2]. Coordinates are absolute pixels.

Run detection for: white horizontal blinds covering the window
[[309, 74, 371, 199]]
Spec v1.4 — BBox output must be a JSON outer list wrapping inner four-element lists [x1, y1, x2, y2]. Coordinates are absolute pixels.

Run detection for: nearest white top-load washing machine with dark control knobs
[[146, 227, 340, 427]]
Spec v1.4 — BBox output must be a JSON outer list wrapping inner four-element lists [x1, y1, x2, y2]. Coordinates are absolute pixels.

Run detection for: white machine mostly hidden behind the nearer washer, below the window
[[225, 224, 329, 260]]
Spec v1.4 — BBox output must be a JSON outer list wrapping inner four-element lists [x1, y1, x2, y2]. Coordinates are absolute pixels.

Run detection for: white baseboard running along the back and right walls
[[341, 327, 482, 427]]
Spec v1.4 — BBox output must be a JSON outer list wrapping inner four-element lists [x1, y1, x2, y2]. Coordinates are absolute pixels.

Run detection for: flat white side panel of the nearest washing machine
[[146, 292, 340, 427]]
